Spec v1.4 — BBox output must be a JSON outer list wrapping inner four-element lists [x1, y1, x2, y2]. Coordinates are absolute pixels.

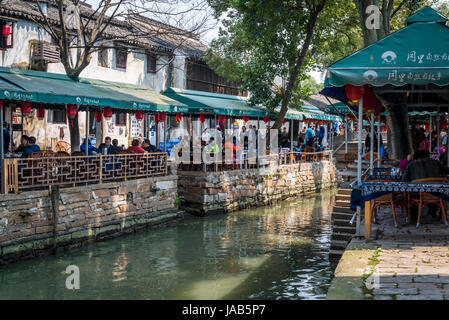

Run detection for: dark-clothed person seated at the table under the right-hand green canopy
[[402, 150, 449, 182]]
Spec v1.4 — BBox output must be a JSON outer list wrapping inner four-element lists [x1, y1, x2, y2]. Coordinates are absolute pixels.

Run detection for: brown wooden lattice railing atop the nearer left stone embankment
[[3, 153, 168, 193]]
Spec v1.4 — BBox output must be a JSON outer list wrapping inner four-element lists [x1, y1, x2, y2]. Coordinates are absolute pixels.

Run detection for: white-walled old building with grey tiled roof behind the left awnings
[[0, 0, 243, 148]]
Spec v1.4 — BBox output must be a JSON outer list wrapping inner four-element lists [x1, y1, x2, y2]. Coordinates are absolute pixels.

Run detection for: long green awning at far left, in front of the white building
[[0, 67, 186, 112]]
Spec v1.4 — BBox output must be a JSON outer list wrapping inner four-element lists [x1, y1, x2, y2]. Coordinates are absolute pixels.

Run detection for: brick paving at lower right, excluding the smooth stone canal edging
[[368, 209, 449, 300]]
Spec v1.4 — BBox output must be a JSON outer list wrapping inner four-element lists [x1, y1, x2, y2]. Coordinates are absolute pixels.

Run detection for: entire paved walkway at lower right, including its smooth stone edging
[[327, 204, 449, 300]]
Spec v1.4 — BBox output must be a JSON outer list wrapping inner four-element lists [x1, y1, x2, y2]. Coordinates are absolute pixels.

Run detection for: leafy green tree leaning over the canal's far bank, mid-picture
[[206, 0, 333, 128]]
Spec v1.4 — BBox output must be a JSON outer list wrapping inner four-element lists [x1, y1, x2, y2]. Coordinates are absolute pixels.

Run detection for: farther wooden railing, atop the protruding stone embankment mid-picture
[[178, 150, 332, 172]]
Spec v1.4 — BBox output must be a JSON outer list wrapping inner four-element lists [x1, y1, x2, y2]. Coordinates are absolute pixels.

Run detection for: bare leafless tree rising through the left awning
[[30, 0, 212, 151]]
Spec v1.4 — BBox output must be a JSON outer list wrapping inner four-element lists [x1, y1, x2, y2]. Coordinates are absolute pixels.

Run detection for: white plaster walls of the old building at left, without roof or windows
[[0, 21, 185, 149]]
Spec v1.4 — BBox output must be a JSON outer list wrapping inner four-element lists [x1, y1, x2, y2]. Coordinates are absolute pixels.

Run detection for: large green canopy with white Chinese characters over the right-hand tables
[[324, 7, 449, 87]]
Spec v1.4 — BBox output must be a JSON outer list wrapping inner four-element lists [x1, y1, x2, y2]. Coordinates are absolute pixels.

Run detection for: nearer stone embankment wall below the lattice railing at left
[[0, 175, 178, 264]]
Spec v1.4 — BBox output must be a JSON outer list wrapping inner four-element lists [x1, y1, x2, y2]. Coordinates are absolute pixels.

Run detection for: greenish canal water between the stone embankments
[[0, 192, 335, 299]]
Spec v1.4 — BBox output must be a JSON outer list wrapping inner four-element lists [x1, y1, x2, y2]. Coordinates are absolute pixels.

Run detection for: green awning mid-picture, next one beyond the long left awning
[[164, 88, 271, 117]]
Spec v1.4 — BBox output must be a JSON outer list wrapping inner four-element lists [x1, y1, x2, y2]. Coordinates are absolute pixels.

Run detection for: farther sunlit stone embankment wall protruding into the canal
[[178, 161, 337, 215]]
